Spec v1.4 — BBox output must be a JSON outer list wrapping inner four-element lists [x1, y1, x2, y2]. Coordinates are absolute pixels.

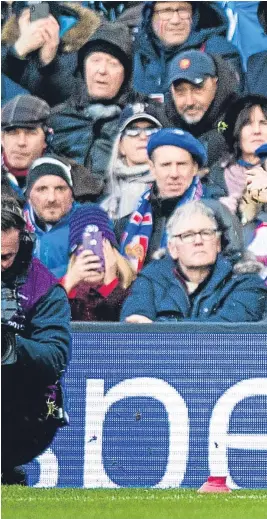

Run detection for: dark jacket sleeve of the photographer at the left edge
[[17, 285, 71, 384]]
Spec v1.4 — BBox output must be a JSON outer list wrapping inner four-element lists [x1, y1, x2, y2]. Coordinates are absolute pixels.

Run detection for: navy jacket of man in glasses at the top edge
[[134, 2, 243, 94]]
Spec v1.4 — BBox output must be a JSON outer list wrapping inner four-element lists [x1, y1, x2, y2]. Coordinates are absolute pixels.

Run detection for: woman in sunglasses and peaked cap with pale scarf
[[101, 103, 161, 220]]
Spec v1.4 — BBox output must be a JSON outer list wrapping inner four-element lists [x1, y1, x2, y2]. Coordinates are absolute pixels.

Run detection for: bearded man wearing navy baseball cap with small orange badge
[[149, 50, 239, 167]]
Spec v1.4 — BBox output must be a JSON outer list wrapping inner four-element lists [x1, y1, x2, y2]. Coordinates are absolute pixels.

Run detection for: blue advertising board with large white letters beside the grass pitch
[[27, 324, 267, 488]]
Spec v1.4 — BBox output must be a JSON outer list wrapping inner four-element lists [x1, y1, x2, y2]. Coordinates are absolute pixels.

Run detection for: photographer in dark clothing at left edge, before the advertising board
[[1, 198, 70, 485]]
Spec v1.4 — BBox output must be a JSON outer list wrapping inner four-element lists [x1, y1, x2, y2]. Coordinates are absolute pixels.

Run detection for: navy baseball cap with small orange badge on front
[[168, 50, 217, 87]]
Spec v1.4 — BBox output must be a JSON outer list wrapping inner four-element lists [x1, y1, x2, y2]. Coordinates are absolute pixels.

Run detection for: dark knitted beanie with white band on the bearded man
[[26, 155, 73, 194]]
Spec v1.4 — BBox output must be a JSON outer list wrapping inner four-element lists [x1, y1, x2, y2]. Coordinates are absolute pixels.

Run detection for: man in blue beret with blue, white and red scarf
[[116, 128, 229, 271]]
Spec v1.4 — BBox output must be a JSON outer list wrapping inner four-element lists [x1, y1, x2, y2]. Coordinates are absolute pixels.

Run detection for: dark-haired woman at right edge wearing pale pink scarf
[[209, 95, 267, 249]]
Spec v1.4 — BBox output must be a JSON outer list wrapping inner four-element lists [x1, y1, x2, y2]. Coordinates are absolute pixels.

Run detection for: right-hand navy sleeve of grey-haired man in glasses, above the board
[[197, 274, 267, 323]]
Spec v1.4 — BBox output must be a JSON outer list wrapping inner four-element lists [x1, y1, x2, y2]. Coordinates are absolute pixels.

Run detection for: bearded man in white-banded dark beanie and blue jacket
[[25, 155, 76, 278]]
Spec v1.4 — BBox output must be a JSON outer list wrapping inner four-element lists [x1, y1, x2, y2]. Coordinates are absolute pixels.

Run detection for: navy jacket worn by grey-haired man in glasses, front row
[[121, 254, 267, 323]]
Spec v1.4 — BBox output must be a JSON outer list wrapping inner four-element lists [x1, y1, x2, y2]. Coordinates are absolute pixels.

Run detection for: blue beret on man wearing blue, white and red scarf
[[147, 128, 208, 168]]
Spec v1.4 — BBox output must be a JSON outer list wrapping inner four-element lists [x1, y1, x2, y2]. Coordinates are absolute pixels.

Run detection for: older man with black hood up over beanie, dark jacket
[[50, 22, 135, 189]]
